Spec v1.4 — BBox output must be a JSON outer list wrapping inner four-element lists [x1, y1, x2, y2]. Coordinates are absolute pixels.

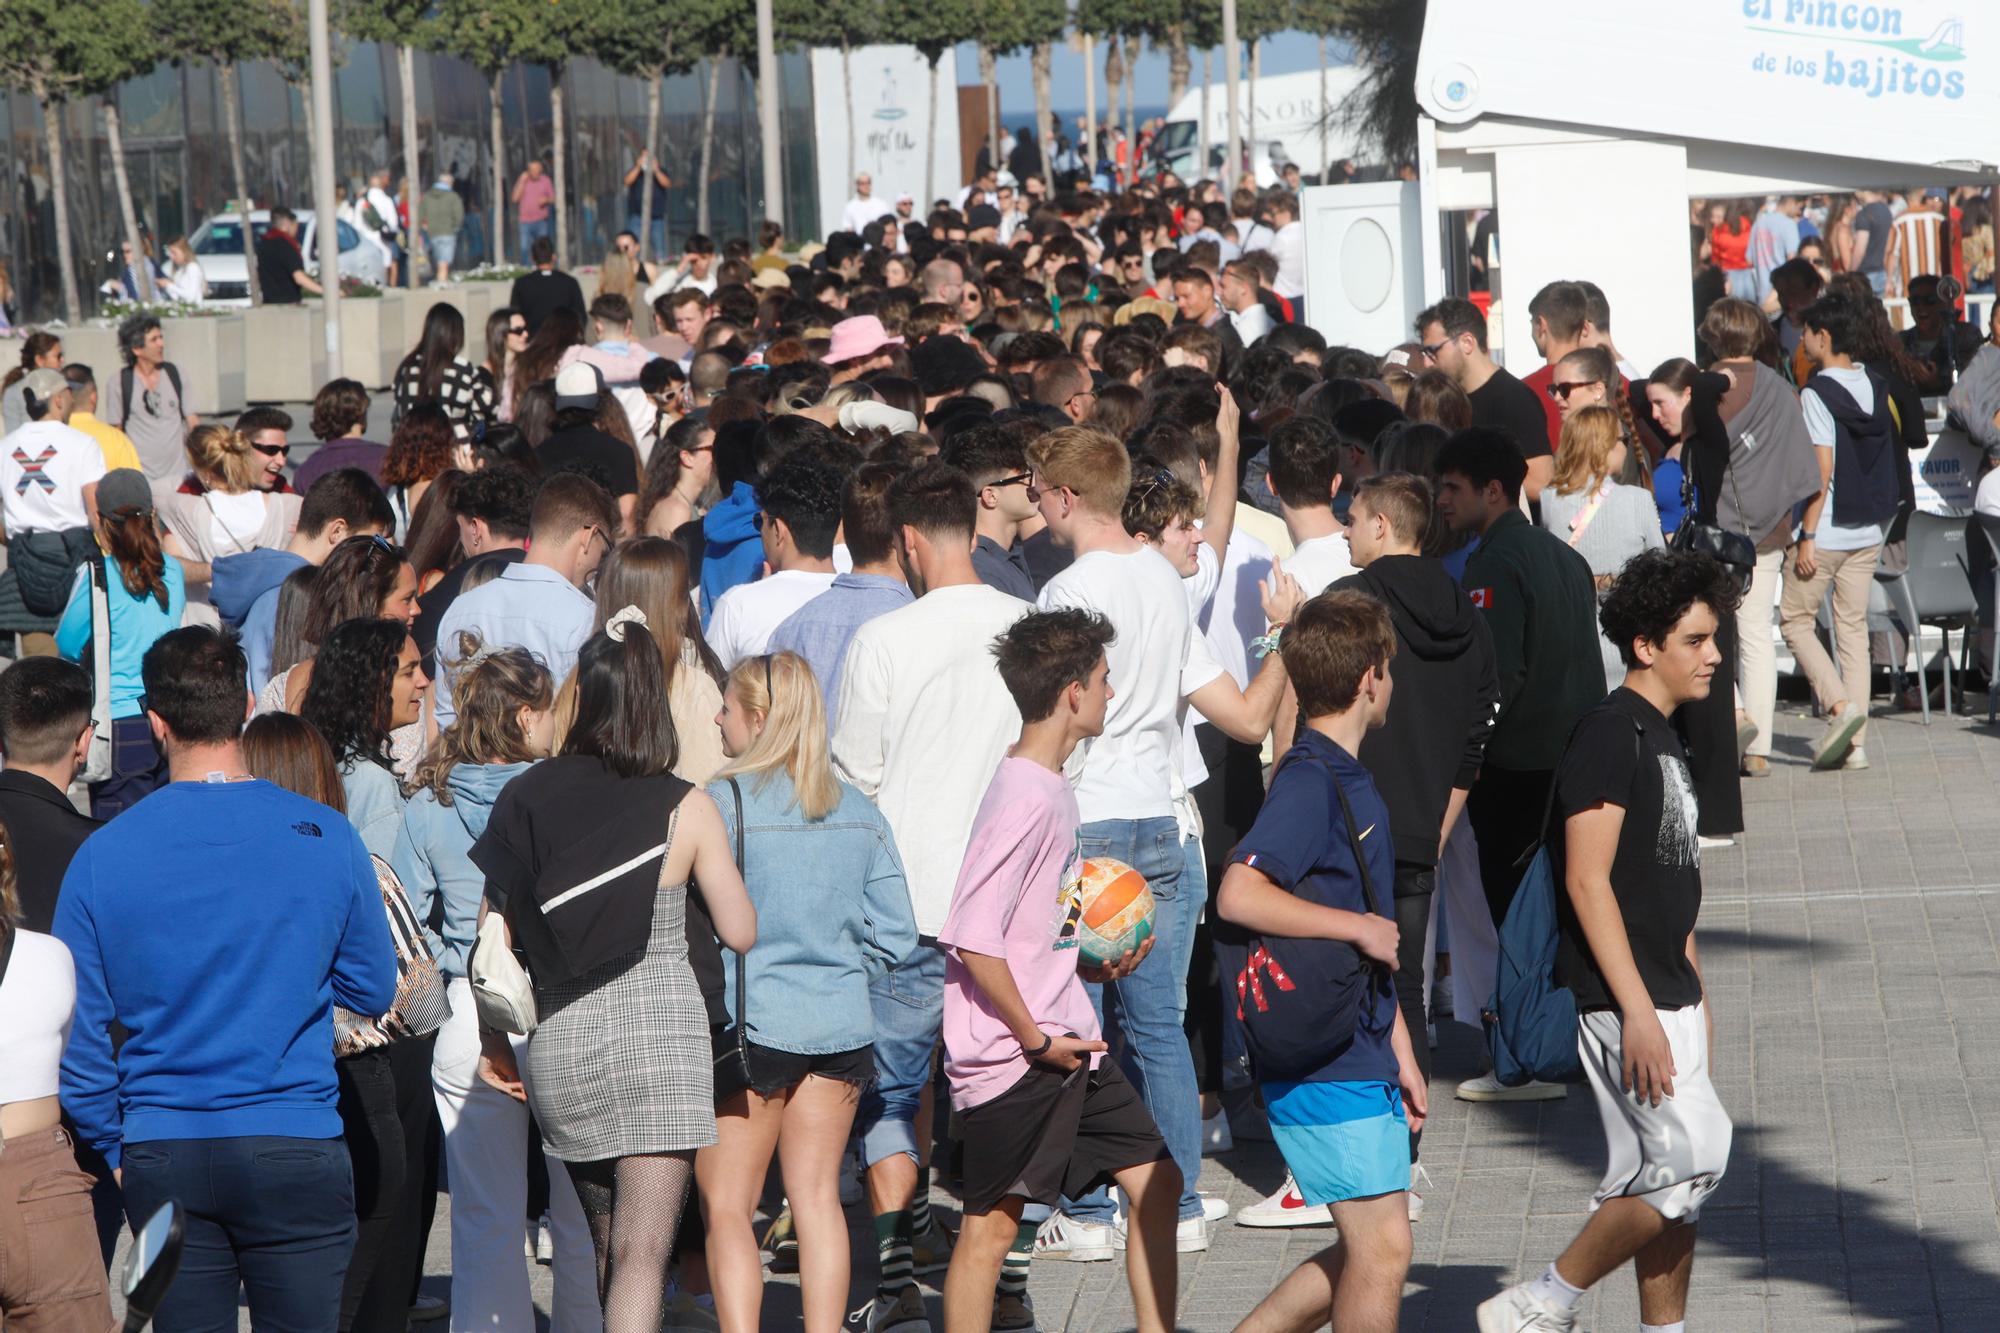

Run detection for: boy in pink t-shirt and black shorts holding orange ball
[[938, 610, 1184, 1333]]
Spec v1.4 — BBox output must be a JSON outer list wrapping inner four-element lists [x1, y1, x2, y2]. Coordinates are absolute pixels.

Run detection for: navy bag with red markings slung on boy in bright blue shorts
[[1216, 759, 1394, 1083]]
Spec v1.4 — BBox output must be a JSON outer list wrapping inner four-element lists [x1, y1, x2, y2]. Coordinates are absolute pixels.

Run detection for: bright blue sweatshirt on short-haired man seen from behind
[[54, 783, 396, 1167]]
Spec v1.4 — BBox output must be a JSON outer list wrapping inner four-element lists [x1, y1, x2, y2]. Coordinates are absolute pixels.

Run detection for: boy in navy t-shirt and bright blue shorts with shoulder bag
[[1218, 592, 1428, 1333]]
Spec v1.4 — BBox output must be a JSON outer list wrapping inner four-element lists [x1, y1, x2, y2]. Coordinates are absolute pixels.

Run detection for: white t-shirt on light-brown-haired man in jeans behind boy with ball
[[1040, 546, 1192, 823]]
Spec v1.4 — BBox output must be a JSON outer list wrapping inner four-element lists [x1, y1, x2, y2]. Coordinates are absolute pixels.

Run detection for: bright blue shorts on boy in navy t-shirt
[[1264, 1083, 1410, 1203]]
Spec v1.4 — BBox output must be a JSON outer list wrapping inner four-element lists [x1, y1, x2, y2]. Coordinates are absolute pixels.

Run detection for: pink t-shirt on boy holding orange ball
[[938, 757, 1102, 1111]]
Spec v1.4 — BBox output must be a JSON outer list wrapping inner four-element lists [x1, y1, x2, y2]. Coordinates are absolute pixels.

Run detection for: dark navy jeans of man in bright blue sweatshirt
[[120, 1137, 354, 1333]]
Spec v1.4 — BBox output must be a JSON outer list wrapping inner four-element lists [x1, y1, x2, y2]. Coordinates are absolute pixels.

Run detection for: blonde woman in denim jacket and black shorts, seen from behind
[[694, 652, 916, 1333]]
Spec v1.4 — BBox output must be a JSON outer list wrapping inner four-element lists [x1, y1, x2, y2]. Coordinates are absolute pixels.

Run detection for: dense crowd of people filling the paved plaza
[[0, 164, 2000, 1333]]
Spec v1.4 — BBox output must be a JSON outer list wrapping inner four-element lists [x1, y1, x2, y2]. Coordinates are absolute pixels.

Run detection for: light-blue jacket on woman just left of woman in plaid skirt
[[388, 765, 534, 977]]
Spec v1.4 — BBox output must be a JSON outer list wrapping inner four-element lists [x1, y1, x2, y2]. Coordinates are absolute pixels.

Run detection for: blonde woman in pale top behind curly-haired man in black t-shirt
[[1542, 404, 1666, 691]]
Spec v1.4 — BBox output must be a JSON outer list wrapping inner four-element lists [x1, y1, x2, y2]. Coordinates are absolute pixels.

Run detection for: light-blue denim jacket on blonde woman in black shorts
[[706, 771, 916, 1055]]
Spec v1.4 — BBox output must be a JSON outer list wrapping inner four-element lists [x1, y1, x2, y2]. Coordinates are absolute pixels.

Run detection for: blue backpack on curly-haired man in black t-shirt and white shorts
[[1480, 723, 1640, 1087]]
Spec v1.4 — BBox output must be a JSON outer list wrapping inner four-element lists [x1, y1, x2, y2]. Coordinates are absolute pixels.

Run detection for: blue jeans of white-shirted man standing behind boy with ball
[[1064, 817, 1208, 1223]]
